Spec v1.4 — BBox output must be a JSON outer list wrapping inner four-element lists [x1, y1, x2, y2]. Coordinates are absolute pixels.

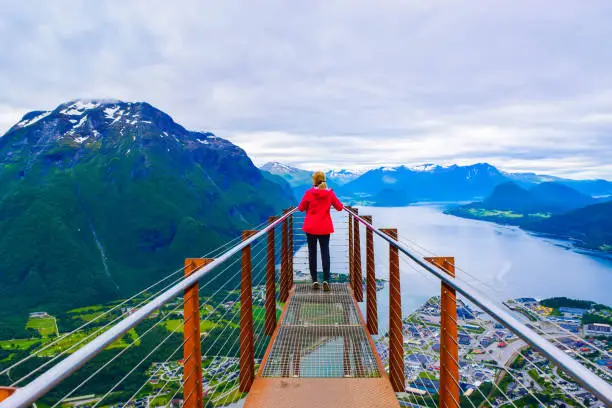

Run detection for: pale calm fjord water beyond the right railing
[[292, 205, 612, 329]]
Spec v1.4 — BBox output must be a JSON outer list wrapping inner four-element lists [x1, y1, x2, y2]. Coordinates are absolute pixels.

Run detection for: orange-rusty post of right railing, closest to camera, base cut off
[[425, 257, 459, 408]]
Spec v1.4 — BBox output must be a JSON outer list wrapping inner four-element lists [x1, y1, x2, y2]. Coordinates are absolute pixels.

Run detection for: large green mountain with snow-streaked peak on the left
[[0, 100, 294, 326]]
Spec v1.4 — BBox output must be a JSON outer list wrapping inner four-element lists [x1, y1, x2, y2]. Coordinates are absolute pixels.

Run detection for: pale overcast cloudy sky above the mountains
[[0, 0, 612, 179]]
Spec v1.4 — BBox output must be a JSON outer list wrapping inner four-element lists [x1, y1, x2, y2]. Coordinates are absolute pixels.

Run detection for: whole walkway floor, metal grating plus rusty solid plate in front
[[244, 282, 399, 408]]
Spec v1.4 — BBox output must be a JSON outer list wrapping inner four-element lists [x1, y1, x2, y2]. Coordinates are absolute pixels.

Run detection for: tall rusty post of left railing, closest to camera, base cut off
[[183, 258, 213, 408]]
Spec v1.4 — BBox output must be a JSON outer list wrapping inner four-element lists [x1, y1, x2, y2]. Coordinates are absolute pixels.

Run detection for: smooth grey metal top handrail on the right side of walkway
[[346, 210, 612, 404]]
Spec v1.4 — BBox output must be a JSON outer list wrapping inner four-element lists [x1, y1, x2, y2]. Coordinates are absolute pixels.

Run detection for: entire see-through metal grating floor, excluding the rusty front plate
[[262, 283, 380, 378]]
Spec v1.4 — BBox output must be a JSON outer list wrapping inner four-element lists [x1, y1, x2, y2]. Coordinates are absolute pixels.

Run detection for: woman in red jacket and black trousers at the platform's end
[[298, 171, 343, 292]]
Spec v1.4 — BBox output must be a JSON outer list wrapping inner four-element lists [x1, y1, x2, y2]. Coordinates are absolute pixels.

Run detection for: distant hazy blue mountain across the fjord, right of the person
[[343, 163, 508, 206]]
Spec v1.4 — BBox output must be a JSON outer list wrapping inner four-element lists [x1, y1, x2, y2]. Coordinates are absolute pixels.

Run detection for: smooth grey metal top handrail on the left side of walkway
[[0, 209, 295, 408]]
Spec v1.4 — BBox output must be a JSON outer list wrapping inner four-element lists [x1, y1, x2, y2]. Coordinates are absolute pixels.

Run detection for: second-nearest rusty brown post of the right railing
[[380, 228, 406, 392]]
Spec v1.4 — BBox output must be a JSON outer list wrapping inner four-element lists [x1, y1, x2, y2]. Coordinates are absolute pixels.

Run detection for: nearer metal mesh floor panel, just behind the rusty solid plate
[[263, 326, 380, 378]]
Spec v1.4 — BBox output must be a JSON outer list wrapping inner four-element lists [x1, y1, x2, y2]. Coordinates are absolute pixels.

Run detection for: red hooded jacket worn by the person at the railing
[[298, 187, 344, 235]]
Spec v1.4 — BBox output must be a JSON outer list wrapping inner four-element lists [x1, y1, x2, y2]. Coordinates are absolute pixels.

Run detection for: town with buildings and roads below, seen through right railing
[[376, 297, 612, 407]]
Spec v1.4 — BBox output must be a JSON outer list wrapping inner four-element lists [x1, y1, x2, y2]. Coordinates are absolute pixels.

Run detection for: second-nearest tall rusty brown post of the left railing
[[239, 230, 257, 392]]
